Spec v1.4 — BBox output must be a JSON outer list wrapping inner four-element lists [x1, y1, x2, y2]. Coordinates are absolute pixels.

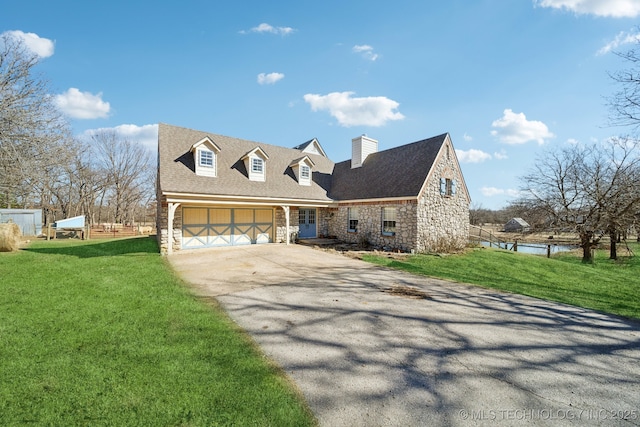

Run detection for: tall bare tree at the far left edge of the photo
[[0, 34, 70, 206]]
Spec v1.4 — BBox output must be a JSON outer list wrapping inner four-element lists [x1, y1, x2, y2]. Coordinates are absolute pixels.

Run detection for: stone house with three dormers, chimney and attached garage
[[157, 124, 470, 253]]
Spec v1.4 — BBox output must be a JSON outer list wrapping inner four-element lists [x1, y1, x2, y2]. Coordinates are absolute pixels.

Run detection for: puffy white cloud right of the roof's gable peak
[[491, 108, 555, 145]]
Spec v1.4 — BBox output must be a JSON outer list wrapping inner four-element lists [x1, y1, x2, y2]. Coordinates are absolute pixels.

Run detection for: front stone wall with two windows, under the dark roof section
[[328, 200, 417, 252]]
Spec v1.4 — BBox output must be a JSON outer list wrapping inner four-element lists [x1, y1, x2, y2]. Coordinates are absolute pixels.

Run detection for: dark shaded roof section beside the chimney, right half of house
[[329, 133, 447, 200]]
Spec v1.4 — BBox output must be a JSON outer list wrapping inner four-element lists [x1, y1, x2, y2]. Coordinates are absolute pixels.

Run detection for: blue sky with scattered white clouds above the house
[[0, 0, 640, 209]]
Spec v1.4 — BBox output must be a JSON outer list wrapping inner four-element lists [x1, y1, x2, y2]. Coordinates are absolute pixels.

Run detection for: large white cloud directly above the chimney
[[304, 92, 404, 127]]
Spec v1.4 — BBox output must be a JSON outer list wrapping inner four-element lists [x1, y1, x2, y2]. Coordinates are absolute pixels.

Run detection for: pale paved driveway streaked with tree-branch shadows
[[169, 244, 640, 426]]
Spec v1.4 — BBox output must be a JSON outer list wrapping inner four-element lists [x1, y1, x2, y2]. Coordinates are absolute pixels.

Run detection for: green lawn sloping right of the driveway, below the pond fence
[[363, 244, 640, 319]]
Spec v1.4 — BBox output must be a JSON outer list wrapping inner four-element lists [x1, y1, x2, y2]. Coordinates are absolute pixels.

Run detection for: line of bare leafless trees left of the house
[[0, 34, 155, 224]]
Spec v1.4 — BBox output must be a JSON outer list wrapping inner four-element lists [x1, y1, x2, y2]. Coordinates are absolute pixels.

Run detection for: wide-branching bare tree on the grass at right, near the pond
[[519, 138, 640, 262]]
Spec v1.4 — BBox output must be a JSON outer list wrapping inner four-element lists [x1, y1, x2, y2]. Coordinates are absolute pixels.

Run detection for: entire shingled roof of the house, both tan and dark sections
[[158, 123, 447, 202]]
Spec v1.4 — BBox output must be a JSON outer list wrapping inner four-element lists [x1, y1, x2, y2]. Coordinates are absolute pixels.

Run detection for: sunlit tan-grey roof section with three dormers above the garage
[[158, 123, 333, 202]]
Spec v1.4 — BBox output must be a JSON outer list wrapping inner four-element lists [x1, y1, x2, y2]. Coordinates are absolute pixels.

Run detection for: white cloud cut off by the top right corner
[[533, 0, 640, 18]]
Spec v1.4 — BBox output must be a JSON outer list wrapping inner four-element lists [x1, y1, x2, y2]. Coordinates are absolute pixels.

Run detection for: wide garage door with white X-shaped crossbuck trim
[[182, 207, 273, 249]]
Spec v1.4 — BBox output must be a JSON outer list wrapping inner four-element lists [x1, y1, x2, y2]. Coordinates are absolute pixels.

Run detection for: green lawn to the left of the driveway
[[0, 238, 315, 426]]
